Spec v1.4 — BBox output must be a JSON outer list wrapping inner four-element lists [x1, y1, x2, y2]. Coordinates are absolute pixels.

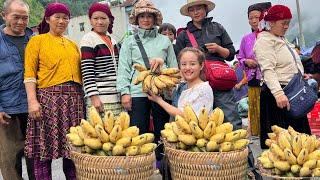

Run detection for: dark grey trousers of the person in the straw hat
[[213, 90, 242, 129]]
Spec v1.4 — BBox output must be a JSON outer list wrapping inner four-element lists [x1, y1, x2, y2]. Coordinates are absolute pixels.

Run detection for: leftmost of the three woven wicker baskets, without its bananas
[[70, 151, 156, 180]]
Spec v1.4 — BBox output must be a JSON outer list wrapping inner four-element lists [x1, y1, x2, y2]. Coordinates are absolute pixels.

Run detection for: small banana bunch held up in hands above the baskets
[[133, 64, 181, 95]]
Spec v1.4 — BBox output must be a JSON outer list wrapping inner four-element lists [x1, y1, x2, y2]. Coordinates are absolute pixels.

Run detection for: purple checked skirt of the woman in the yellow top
[[25, 82, 85, 160]]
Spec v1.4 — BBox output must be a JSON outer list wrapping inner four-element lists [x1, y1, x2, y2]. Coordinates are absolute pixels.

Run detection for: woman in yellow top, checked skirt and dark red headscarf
[[24, 3, 84, 180]]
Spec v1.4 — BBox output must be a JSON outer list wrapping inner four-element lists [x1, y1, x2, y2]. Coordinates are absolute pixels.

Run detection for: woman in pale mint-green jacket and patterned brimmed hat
[[117, 0, 178, 163]]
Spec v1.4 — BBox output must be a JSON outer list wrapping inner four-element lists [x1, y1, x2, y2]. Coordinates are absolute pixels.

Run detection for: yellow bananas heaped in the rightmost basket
[[258, 125, 320, 177]]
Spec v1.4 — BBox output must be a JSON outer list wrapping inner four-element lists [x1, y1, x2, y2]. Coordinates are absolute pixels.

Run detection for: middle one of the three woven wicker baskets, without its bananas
[[164, 142, 248, 180]]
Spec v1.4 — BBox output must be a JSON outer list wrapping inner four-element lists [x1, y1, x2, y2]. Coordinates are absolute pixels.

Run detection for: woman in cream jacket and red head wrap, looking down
[[254, 5, 311, 149]]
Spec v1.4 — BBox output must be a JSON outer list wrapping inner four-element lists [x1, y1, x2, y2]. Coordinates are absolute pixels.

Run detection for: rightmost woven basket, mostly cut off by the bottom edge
[[256, 160, 314, 180]]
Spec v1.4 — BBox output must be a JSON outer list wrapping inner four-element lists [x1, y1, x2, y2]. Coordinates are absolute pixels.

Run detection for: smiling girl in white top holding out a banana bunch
[[148, 47, 213, 116]]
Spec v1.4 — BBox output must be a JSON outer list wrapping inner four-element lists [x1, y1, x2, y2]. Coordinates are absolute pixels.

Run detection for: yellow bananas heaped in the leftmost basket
[[67, 108, 157, 156]]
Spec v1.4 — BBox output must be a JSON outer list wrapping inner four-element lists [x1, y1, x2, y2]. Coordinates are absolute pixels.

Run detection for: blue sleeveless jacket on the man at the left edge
[[0, 25, 33, 114]]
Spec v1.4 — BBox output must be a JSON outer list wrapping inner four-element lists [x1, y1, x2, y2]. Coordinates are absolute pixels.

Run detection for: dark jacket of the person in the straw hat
[[176, 18, 235, 61]]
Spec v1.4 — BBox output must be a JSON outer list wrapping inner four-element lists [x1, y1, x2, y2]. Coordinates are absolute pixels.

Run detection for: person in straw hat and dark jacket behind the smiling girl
[[176, 0, 242, 129]]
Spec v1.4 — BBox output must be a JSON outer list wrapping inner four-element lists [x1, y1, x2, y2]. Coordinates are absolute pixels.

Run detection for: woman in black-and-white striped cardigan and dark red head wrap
[[80, 2, 122, 120]]
